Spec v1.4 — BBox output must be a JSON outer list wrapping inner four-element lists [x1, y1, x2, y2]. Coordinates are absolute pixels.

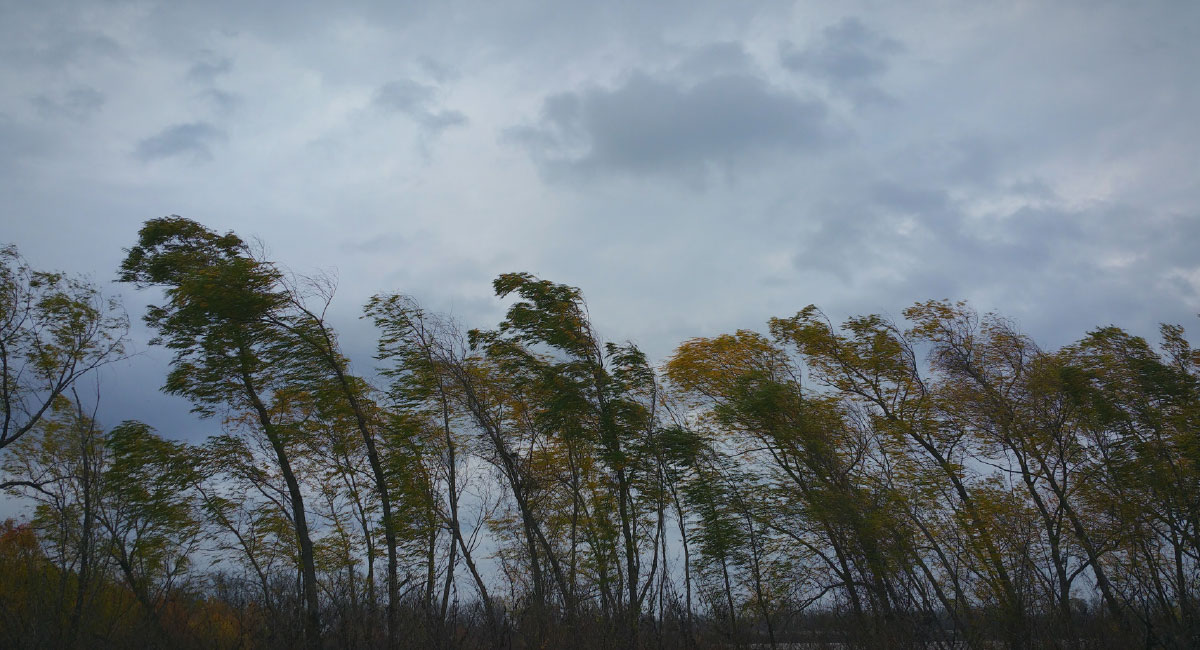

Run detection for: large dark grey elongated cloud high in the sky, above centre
[[508, 63, 833, 179]]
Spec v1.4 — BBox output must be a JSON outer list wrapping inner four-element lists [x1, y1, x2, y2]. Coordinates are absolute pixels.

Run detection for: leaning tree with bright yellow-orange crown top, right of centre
[[667, 331, 911, 650]]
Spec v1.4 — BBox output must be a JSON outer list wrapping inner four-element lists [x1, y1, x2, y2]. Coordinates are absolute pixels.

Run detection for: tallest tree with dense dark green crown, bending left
[[120, 217, 320, 648]]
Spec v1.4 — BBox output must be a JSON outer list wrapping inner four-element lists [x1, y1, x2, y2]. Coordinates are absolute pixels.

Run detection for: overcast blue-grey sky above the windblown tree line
[[0, 0, 1200, 446]]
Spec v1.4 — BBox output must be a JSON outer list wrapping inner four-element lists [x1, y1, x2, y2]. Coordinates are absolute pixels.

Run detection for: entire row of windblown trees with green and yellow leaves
[[0, 217, 1200, 649]]
